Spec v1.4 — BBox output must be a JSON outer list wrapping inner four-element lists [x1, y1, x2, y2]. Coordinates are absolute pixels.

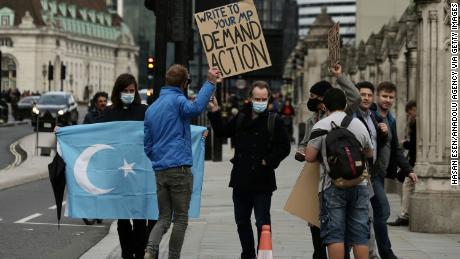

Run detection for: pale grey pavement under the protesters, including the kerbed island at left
[[0, 133, 460, 259]]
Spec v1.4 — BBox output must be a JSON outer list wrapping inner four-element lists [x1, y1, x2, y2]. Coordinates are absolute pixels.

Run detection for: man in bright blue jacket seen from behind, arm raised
[[144, 65, 221, 258]]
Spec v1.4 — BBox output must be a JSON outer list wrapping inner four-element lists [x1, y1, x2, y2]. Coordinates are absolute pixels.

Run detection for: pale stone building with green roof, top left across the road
[[0, 0, 139, 100]]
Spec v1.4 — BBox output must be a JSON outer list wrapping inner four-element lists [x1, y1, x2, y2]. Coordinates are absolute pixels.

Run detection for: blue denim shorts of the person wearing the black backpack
[[320, 185, 369, 246]]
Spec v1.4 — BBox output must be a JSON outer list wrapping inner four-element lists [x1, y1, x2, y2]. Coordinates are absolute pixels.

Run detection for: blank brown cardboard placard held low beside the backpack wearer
[[284, 162, 320, 227]]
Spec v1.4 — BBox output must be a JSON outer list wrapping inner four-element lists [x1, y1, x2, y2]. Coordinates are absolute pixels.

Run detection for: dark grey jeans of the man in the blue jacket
[[147, 167, 193, 259]]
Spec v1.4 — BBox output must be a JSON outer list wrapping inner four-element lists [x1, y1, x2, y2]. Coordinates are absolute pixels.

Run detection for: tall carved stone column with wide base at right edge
[[409, 0, 460, 233]]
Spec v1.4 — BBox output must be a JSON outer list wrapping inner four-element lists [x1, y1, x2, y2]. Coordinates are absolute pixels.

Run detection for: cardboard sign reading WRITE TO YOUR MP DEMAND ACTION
[[195, 0, 272, 78]]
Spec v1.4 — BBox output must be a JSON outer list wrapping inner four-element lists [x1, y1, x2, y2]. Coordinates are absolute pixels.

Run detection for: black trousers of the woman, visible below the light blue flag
[[117, 219, 156, 259]]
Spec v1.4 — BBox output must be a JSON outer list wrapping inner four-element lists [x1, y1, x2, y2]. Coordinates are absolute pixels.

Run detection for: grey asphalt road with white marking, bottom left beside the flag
[[0, 179, 111, 259]]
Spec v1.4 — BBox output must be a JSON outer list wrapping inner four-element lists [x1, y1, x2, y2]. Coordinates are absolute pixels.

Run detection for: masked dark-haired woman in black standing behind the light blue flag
[[100, 74, 156, 259]]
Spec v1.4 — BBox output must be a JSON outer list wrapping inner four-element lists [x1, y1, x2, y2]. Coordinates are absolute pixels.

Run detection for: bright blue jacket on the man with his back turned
[[144, 82, 214, 171]]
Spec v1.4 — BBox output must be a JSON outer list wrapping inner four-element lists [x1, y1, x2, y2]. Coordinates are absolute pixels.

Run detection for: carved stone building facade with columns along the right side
[[285, 0, 460, 233]]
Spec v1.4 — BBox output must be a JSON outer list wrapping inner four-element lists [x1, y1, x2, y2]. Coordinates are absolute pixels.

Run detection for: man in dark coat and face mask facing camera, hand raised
[[208, 81, 291, 259]]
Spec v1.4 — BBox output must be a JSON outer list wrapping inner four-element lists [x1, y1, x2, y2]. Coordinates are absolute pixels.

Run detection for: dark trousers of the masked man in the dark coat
[[233, 189, 272, 259]]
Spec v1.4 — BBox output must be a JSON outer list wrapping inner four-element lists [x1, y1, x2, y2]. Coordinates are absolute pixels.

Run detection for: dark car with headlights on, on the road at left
[[32, 92, 78, 131]]
